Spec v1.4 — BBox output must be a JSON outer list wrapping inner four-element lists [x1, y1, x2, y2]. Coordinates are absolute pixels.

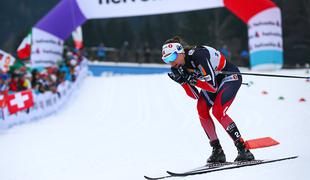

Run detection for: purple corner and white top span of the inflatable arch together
[[35, 0, 223, 40]]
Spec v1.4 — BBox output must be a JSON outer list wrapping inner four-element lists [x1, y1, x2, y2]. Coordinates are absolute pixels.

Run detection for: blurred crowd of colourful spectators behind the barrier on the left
[[0, 48, 82, 94]]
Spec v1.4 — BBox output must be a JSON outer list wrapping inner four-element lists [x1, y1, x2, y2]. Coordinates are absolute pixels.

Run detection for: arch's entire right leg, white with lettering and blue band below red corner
[[248, 7, 283, 70]]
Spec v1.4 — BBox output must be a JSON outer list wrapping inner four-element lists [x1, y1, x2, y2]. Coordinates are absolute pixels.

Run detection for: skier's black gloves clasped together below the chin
[[168, 66, 197, 86]]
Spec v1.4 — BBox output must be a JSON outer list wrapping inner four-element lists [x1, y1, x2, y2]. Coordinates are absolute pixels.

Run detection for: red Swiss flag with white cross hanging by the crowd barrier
[[6, 90, 34, 114]]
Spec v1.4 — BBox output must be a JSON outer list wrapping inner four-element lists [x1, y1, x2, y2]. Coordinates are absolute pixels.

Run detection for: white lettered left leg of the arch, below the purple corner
[[31, 28, 64, 67]]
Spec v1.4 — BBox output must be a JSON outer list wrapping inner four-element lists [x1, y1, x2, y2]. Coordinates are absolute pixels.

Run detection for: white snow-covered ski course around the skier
[[0, 70, 310, 180]]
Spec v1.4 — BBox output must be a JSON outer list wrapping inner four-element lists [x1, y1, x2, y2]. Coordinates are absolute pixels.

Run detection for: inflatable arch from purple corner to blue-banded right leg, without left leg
[[35, 0, 283, 69]]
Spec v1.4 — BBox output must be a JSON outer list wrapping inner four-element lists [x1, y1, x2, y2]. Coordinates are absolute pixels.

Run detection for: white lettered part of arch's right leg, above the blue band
[[248, 7, 283, 53]]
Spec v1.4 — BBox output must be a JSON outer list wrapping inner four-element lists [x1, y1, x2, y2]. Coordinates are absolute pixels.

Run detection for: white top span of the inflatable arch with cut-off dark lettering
[[76, 0, 224, 19]]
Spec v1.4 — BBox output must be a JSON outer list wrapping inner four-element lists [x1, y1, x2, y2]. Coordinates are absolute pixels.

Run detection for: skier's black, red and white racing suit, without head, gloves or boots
[[182, 46, 242, 141]]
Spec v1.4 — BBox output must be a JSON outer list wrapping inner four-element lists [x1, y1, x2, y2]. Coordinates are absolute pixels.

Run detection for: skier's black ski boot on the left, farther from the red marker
[[207, 140, 226, 164]]
